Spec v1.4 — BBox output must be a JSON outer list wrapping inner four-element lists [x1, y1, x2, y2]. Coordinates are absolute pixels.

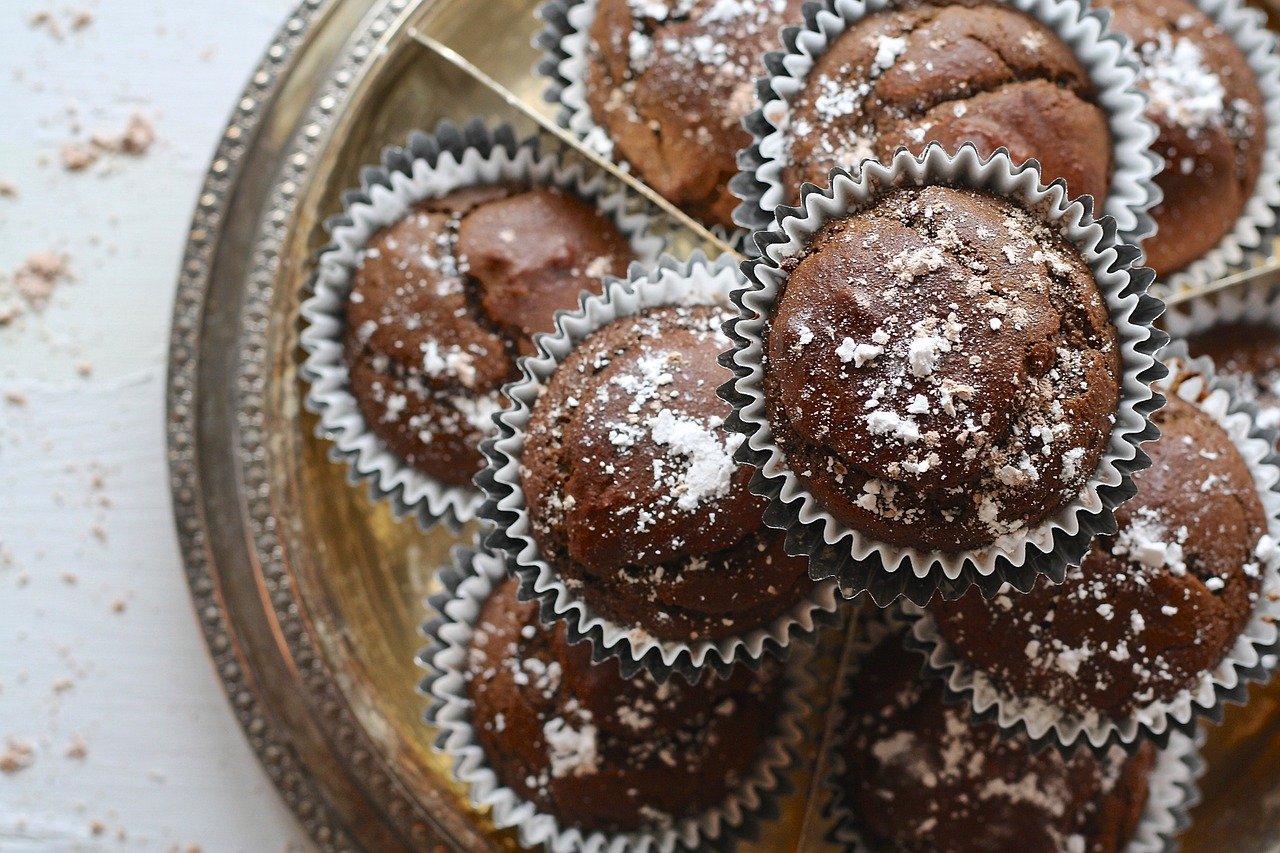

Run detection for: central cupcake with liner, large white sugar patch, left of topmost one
[[479, 256, 835, 679]]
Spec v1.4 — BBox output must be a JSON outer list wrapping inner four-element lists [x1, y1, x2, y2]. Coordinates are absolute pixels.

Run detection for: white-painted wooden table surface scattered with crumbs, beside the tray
[[0, 0, 307, 853]]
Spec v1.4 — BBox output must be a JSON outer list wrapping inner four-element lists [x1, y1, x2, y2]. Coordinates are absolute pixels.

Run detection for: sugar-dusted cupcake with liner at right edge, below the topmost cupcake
[[908, 351, 1280, 748]]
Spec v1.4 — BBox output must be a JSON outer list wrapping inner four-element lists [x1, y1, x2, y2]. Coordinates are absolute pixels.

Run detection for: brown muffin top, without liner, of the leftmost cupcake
[[343, 186, 634, 485]]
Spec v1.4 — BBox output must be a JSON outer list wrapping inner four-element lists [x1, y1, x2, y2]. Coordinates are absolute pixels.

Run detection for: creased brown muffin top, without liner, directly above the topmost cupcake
[[783, 0, 1112, 207]]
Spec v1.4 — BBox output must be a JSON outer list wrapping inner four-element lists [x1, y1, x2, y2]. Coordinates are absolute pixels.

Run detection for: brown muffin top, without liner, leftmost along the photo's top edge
[[586, 0, 804, 229]]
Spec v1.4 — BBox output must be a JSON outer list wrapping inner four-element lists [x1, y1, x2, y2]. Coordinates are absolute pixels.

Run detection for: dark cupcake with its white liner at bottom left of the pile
[[421, 552, 812, 850]]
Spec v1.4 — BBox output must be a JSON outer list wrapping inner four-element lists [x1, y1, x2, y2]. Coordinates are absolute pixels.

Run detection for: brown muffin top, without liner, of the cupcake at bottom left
[[466, 579, 783, 831]]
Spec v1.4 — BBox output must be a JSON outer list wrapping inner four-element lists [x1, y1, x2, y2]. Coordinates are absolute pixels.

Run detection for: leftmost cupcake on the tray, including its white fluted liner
[[301, 123, 663, 525]]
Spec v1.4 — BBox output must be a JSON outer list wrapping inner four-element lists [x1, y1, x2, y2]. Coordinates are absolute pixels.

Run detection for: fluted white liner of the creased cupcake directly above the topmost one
[[730, 0, 1164, 251]]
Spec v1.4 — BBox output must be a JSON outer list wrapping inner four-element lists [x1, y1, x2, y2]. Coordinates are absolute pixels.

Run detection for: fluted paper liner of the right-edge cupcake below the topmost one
[[900, 342, 1280, 752]]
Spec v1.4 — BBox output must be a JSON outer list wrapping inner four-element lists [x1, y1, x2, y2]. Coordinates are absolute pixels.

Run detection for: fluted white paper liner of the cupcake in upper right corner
[[1156, 0, 1280, 295]]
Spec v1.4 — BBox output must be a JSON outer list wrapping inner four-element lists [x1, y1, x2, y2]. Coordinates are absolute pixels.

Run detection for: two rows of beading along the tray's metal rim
[[166, 0, 453, 850]]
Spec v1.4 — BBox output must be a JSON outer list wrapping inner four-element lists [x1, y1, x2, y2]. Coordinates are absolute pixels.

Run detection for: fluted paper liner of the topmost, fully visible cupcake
[[721, 145, 1167, 606]]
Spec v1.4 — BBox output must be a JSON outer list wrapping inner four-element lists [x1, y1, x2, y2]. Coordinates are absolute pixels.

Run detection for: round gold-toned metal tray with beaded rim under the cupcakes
[[169, 0, 1280, 850]]
